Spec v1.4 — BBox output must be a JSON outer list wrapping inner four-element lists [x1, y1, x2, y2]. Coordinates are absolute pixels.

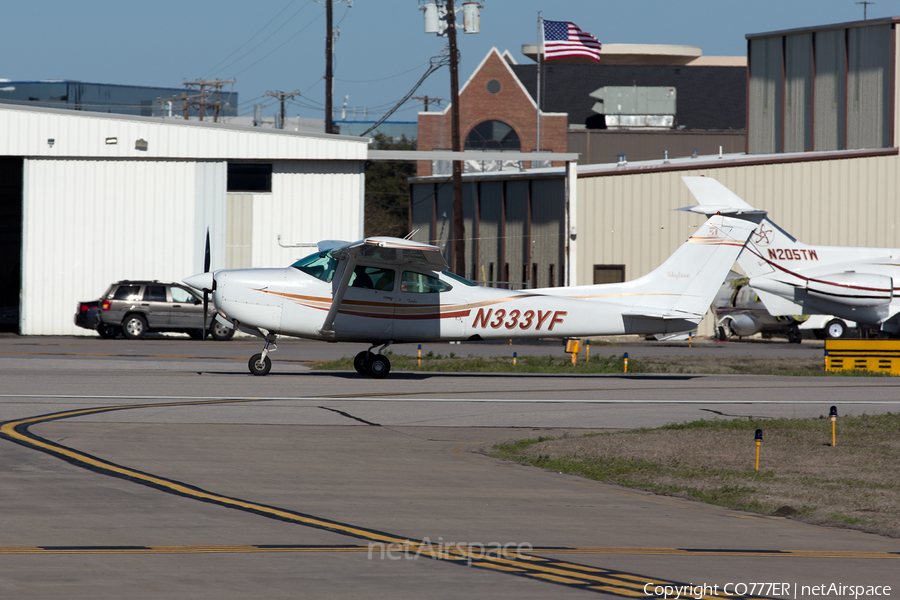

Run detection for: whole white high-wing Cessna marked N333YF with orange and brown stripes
[[184, 216, 754, 379]]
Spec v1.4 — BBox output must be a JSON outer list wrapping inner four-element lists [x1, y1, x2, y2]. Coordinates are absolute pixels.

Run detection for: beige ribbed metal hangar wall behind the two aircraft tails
[[576, 156, 900, 335]]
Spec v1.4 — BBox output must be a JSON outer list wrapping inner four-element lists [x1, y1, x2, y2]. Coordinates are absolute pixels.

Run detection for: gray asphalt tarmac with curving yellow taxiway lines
[[0, 336, 900, 598]]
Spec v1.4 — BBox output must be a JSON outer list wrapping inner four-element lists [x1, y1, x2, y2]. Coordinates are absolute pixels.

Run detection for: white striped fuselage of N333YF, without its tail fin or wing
[[213, 267, 696, 343]]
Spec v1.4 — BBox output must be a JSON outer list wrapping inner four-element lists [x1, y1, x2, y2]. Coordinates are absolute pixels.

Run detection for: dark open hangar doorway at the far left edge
[[0, 157, 23, 333]]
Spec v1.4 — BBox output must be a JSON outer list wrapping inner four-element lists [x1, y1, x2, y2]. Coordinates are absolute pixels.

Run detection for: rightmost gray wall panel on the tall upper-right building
[[847, 24, 892, 148]]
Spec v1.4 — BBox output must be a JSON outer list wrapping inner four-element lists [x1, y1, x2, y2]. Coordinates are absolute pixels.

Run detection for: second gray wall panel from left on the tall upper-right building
[[784, 33, 813, 152]]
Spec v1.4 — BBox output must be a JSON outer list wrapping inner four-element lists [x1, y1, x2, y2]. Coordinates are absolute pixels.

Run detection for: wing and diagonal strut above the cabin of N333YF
[[319, 237, 449, 337]]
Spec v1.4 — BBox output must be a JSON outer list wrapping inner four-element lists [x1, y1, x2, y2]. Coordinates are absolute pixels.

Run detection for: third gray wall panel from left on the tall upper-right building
[[815, 29, 847, 150]]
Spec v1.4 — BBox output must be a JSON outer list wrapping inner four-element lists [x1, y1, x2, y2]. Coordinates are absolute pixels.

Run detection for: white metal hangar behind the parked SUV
[[0, 104, 368, 335]]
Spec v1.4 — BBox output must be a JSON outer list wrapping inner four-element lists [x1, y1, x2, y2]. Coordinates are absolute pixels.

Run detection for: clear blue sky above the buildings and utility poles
[[0, 0, 884, 121]]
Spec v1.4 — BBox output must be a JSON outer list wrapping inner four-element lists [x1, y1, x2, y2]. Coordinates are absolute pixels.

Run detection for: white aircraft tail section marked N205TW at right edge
[[678, 177, 900, 334]]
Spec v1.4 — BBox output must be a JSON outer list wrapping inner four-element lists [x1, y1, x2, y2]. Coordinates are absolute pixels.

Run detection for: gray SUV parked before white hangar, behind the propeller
[[98, 281, 234, 340]]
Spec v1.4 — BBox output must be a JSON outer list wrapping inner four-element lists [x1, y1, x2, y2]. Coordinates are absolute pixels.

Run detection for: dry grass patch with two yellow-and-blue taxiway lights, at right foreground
[[486, 413, 900, 537]]
